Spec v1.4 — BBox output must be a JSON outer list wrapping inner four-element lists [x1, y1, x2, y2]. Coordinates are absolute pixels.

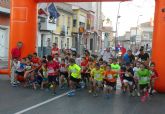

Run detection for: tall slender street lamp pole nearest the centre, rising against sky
[[115, 2, 122, 57]]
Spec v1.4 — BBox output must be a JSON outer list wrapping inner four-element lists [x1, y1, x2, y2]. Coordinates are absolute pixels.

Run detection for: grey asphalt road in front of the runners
[[0, 76, 165, 114]]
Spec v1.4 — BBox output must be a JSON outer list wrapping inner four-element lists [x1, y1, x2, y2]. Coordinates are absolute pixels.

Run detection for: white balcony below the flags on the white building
[[39, 17, 56, 31]]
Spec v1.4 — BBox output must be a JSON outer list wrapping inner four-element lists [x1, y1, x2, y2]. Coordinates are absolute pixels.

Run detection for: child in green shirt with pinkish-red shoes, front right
[[137, 63, 151, 102]]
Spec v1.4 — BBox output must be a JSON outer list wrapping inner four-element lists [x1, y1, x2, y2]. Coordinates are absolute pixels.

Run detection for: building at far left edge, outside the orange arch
[[0, 0, 10, 61]]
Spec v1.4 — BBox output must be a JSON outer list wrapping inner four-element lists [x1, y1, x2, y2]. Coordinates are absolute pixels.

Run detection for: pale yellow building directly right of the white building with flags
[[53, 3, 73, 49]]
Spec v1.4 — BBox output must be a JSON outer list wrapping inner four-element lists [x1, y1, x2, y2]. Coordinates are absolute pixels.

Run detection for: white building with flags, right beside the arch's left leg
[[37, 3, 56, 56]]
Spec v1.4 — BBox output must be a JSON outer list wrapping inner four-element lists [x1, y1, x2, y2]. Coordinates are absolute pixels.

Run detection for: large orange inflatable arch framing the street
[[0, 0, 165, 92]]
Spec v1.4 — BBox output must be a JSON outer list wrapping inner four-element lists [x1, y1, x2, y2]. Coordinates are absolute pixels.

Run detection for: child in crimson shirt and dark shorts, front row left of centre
[[47, 55, 59, 95]]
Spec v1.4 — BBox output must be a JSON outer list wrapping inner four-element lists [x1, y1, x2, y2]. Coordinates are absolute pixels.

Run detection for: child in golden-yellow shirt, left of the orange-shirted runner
[[91, 63, 104, 97]]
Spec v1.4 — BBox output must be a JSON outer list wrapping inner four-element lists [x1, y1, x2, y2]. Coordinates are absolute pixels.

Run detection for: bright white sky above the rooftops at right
[[102, 0, 155, 35]]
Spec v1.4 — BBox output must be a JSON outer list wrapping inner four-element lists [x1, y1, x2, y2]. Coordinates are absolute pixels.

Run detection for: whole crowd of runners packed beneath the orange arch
[[11, 42, 158, 102]]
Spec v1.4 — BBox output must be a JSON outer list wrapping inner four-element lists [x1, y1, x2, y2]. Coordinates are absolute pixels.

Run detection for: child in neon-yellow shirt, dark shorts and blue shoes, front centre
[[68, 58, 81, 96]]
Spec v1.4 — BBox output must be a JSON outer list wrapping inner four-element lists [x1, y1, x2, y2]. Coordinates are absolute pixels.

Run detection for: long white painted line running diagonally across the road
[[14, 92, 68, 114]]
